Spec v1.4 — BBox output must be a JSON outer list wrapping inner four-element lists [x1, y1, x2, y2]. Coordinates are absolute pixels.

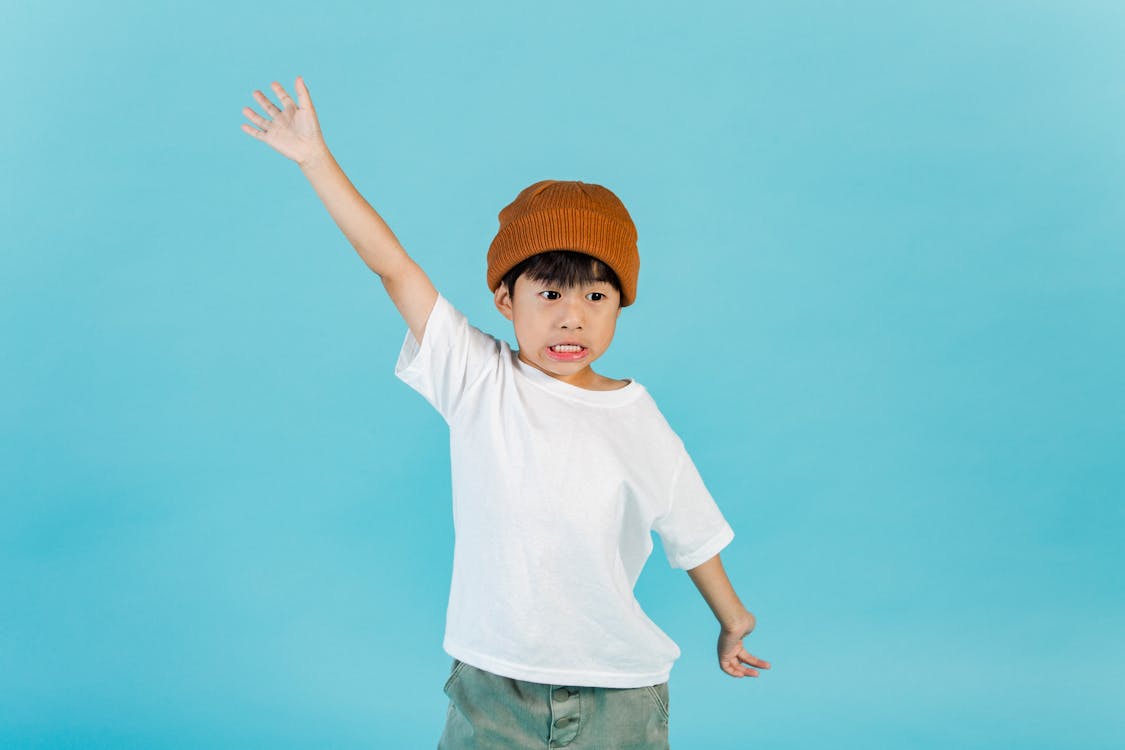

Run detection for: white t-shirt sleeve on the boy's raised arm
[[395, 293, 500, 423]]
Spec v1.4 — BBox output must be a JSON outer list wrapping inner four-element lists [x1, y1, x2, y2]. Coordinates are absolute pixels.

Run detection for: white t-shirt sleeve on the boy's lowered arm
[[653, 451, 735, 570]]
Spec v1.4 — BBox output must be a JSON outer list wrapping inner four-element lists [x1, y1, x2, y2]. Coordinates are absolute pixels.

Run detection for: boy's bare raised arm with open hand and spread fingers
[[242, 76, 438, 341]]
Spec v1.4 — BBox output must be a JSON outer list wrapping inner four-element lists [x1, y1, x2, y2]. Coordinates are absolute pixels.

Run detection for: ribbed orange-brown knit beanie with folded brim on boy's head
[[488, 180, 640, 307]]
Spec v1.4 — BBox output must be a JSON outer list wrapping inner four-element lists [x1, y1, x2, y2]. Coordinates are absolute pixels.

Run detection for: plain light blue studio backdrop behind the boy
[[0, 0, 1125, 750]]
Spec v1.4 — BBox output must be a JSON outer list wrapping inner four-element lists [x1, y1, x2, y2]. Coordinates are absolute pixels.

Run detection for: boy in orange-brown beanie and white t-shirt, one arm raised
[[242, 76, 770, 750]]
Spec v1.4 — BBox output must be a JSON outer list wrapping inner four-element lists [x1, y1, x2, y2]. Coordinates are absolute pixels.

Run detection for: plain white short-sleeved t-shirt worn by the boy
[[395, 295, 735, 687]]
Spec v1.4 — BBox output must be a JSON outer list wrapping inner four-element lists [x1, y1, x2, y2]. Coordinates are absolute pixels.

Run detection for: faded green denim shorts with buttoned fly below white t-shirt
[[438, 659, 668, 750]]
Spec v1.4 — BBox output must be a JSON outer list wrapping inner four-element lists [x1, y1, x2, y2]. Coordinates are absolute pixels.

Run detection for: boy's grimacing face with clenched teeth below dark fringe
[[496, 274, 621, 388]]
